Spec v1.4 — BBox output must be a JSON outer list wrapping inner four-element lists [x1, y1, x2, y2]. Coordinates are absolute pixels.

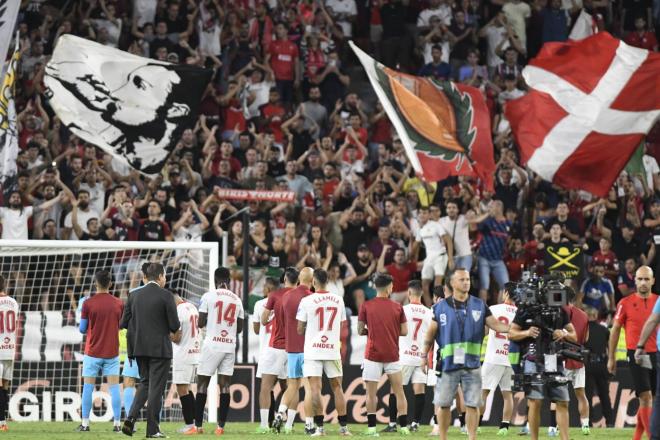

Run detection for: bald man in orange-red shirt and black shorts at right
[[607, 266, 658, 440]]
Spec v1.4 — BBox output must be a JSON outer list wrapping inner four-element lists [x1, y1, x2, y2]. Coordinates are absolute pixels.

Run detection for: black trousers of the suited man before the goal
[[128, 357, 172, 436]]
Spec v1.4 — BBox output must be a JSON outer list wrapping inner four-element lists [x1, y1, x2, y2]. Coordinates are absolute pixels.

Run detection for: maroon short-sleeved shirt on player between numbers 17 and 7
[[358, 297, 407, 362]]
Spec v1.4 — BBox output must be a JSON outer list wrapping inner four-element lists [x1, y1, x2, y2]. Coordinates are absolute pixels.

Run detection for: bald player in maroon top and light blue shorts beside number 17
[[273, 267, 315, 434]]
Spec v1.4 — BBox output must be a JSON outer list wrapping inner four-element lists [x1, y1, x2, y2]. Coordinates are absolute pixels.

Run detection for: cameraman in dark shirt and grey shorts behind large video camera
[[509, 292, 577, 440]]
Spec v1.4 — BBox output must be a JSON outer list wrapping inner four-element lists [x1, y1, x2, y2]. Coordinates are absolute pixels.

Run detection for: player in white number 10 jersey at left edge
[[0, 275, 20, 431]]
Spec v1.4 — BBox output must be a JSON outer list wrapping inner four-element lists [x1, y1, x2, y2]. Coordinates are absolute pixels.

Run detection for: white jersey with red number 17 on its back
[[296, 292, 346, 361]]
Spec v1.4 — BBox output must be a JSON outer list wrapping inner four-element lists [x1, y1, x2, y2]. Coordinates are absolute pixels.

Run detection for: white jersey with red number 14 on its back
[[199, 289, 244, 353]]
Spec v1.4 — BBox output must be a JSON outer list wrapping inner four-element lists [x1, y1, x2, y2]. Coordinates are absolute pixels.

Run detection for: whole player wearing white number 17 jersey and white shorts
[[296, 269, 351, 437]]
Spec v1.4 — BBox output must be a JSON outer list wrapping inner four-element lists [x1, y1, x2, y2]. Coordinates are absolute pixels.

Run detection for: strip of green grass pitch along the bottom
[[0, 422, 633, 440]]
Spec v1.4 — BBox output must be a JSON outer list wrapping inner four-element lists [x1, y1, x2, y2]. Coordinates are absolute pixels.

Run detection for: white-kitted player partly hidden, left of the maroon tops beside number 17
[[252, 277, 286, 433]]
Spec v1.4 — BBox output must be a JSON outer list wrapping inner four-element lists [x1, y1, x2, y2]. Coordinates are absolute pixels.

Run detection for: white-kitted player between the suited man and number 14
[[172, 295, 201, 434]]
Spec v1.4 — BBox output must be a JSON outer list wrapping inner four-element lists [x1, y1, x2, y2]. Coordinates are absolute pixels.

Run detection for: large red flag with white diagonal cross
[[506, 32, 660, 196]]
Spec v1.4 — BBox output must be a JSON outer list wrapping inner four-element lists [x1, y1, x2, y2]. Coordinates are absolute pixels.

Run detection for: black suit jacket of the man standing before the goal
[[120, 282, 181, 359]]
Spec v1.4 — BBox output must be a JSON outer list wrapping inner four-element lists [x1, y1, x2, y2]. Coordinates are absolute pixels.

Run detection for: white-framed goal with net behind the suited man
[[0, 240, 219, 421]]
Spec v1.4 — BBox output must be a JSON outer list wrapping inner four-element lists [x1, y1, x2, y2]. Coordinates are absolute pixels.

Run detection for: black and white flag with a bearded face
[[44, 34, 212, 174]]
